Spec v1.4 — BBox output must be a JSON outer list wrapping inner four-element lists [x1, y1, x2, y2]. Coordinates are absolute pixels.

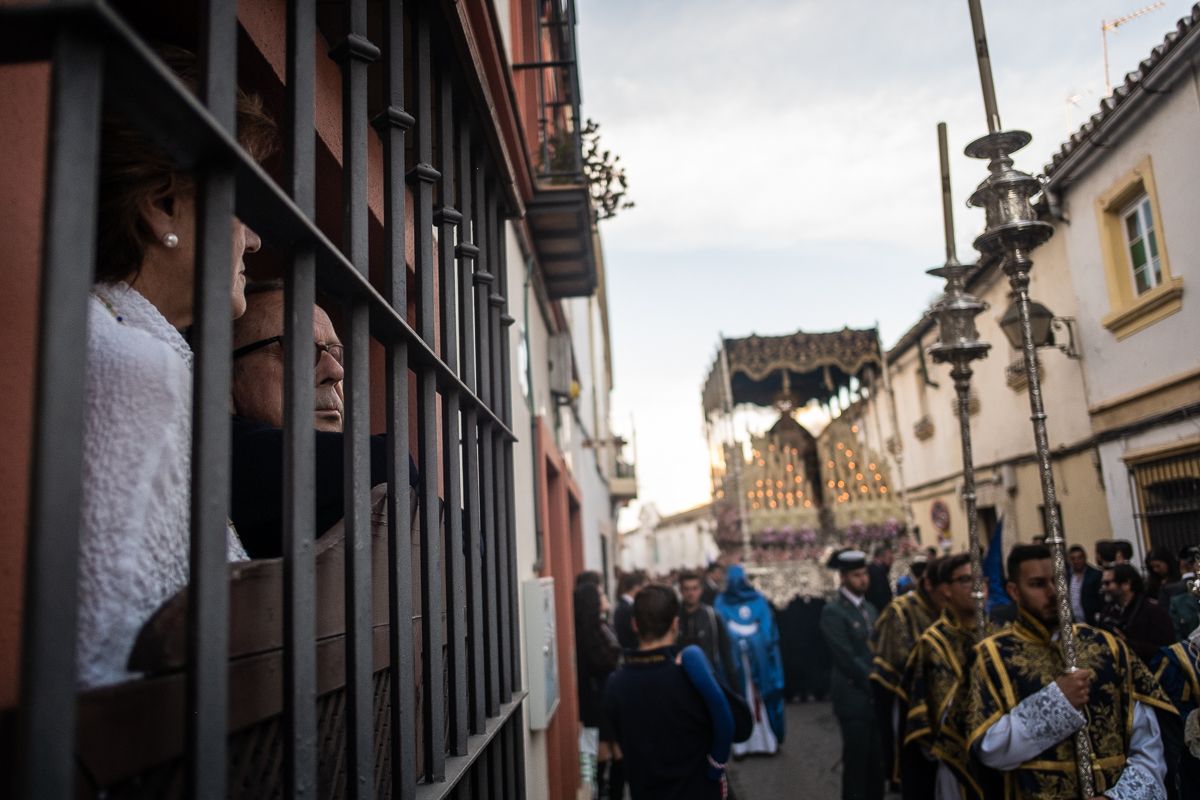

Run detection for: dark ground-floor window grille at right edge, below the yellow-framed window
[[1129, 450, 1200, 553]]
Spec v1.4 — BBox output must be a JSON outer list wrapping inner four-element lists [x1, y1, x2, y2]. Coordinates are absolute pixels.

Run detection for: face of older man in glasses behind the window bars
[[233, 291, 343, 432]]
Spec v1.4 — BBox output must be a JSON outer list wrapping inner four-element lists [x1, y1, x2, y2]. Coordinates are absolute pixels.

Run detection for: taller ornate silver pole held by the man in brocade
[[966, 0, 1096, 799]]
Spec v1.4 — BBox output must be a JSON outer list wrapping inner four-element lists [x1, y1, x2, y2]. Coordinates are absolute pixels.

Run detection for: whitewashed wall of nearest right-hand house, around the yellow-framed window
[[1057, 47, 1200, 563]]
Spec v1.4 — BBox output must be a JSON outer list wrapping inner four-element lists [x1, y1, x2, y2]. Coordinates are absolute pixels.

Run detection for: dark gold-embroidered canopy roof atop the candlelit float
[[703, 327, 881, 416]]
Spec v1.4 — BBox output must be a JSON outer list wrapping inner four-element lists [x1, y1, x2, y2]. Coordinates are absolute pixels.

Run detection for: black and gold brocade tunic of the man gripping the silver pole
[[966, 609, 1177, 799]]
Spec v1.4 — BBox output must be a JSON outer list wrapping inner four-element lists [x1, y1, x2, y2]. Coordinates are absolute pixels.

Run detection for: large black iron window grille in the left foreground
[[0, 0, 525, 799]]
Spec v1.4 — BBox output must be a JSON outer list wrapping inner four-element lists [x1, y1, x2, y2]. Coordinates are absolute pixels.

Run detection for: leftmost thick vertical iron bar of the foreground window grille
[[14, 26, 103, 800]]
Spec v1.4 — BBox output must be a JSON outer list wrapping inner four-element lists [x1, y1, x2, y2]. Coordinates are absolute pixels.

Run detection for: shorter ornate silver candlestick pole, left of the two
[[929, 122, 991, 639]]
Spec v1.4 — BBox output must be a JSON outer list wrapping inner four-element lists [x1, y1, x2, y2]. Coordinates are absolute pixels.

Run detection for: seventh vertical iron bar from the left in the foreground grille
[[437, 53, 468, 756]]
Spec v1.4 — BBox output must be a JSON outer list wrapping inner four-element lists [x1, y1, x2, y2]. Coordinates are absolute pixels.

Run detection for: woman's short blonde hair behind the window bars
[[96, 46, 280, 282]]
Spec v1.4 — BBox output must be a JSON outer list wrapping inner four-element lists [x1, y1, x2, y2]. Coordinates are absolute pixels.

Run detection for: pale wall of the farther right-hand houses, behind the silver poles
[[859, 221, 1110, 549]]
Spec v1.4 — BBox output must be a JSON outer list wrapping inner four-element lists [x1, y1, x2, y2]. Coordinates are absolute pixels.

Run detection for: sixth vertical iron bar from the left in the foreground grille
[[410, 0, 454, 782]]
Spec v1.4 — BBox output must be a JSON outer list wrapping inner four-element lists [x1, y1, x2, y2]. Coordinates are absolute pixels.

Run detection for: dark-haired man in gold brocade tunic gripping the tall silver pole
[[965, 545, 1178, 800]]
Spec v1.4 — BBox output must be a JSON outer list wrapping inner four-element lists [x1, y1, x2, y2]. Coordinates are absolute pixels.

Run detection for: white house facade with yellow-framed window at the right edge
[[1046, 8, 1200, 563]]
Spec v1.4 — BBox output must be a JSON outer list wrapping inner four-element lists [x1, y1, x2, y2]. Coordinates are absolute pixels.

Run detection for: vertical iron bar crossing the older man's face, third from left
[[283, 0, 317, 799]]
